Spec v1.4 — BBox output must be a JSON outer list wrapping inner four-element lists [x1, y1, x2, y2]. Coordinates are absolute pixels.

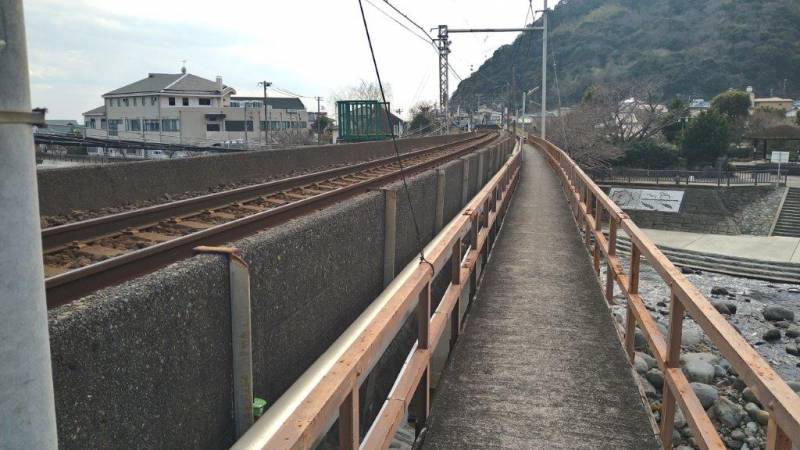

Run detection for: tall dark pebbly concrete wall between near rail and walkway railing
[[49, 139, 510, 449]]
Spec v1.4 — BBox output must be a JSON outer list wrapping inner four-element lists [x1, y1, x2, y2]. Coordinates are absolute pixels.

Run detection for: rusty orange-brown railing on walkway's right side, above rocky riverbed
[[528, 136, 800, 450]]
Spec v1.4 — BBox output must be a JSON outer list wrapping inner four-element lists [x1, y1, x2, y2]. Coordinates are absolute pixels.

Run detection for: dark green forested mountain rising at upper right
[[450, 0, 800, 109]]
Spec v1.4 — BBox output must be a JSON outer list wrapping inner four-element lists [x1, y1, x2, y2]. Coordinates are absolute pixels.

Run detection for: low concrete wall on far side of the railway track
[[38, 135, 476, 215]]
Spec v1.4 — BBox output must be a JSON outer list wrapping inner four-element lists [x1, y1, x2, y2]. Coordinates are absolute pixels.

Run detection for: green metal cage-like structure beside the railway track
[[336, 100, 393, 142]]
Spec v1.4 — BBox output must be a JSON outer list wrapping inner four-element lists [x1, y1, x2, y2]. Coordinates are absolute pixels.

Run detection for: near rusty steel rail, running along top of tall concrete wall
[[45, 136, 506, 308]]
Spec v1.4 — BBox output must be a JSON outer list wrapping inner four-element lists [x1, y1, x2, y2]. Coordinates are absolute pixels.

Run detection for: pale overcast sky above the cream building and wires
[[25, 0, 557, 119]]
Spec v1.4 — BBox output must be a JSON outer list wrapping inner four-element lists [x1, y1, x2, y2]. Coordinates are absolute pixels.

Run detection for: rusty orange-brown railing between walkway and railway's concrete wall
[[232, 139, 521, 449]]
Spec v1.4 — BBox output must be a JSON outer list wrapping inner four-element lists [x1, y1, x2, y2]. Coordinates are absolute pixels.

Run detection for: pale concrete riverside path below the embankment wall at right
[[636, 229, 800, 263]]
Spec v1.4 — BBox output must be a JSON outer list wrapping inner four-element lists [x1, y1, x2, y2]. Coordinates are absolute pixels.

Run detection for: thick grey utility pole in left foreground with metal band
[[0, 0, 58, 450]]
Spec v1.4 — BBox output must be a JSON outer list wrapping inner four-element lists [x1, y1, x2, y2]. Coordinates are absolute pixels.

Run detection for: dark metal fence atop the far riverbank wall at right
[[586, 168, 787, 186]]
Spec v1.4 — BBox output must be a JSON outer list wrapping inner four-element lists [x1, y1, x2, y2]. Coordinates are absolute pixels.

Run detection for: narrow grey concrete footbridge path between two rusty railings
[[424, 147, 658, 449]]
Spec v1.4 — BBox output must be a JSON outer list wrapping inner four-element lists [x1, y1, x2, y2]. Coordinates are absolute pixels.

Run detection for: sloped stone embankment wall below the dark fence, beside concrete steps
[[604, 184, 786, 236]]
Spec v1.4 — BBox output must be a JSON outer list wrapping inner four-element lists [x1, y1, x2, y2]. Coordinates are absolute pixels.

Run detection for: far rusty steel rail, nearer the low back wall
[[42, 133, 488, 253]]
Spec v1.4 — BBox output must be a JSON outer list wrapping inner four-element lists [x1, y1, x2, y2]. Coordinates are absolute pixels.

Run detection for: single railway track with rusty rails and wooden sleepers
[[42, 133, 502, 308]]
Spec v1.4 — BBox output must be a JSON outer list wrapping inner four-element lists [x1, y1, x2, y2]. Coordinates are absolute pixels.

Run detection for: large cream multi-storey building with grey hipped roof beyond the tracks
[[83, 68, 308, 146]]
